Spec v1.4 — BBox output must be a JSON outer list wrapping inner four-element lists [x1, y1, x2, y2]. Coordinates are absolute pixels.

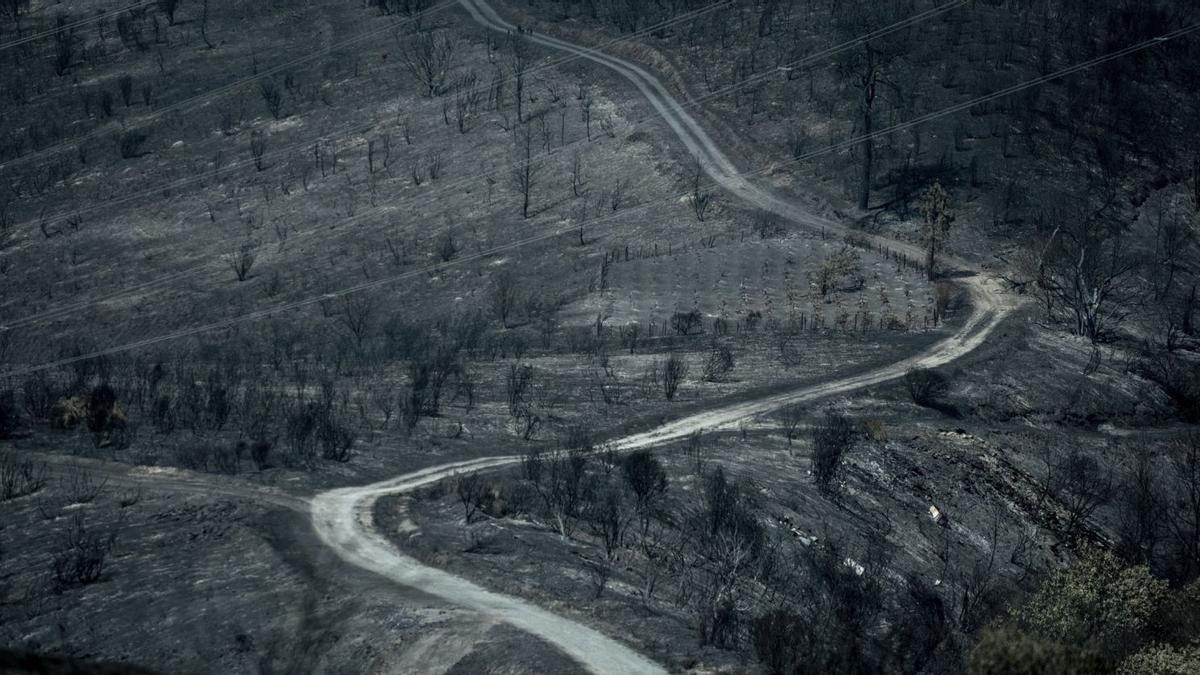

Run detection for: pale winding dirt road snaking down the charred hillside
[[311, 0, 1014, 673]]
